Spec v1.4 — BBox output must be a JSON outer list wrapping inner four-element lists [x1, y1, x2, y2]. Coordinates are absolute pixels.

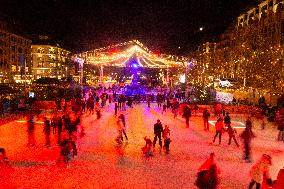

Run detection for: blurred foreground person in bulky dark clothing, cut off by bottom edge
[[195, 153, 220, 189]]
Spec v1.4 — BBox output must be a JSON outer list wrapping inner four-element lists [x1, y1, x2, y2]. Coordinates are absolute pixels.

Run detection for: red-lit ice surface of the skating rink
[[0, 104, 284, 189]]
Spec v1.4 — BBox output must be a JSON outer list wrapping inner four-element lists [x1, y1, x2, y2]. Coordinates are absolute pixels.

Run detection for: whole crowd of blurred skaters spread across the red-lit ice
[[0, 86, 284, 189]]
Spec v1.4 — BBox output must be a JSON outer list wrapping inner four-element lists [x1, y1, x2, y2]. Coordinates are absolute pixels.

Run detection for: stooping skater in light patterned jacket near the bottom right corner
[[248, 154, 273, 189]]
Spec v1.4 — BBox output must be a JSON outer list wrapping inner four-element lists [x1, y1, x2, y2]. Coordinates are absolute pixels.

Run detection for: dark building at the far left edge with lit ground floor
[[0, 20, 32, 83]]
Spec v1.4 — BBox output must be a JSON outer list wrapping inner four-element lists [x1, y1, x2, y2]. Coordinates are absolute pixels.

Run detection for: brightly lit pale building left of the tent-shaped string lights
[[31, 45, 73, 80]]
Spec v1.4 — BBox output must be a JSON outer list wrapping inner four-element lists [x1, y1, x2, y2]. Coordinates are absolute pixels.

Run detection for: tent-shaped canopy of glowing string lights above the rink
[[73, 40, 188, 68]]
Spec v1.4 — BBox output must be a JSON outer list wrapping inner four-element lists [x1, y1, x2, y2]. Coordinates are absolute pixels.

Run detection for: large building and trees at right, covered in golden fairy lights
[[193, 0, 284, 93]]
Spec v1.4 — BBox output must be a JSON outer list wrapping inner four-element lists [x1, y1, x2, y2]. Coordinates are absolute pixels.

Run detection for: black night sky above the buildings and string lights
[[0, 0, 257, 54]]
